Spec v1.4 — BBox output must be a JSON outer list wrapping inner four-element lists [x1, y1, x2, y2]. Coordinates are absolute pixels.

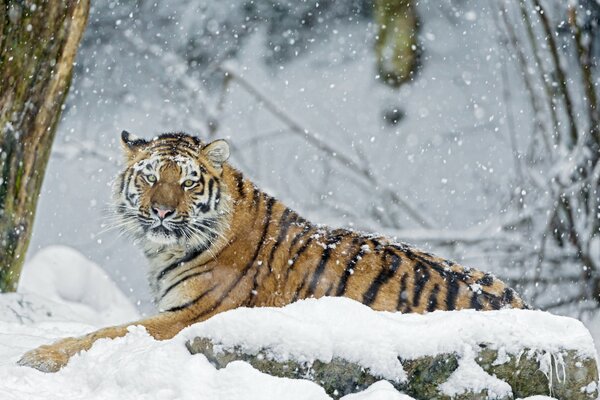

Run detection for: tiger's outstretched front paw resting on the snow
[[17, 338, 86, 372]]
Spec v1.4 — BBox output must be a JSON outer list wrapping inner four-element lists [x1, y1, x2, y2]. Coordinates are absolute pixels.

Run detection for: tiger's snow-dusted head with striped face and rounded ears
[[115, 131, 229, 249]]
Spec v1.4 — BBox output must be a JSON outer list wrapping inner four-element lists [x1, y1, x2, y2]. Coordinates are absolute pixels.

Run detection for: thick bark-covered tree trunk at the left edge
[[0, 0, 89, 292]]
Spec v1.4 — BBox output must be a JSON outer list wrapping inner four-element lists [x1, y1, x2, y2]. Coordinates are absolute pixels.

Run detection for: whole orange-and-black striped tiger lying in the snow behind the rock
[[19, 131, 527, 372]]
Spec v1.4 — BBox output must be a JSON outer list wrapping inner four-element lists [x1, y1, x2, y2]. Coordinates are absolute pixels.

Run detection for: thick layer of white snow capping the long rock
[[182, 297, 596, 382]]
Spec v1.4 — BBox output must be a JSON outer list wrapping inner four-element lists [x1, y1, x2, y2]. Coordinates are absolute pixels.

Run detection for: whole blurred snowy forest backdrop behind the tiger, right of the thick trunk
[[16, 0, 600, 319]]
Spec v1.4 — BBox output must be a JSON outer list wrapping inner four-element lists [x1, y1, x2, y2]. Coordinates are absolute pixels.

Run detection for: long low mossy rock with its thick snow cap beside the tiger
[[181, 298, 598, 400]]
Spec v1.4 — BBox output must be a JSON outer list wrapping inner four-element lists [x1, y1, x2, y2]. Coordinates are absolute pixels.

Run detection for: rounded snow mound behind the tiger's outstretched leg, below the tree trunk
[[18, 246, 139, 326]]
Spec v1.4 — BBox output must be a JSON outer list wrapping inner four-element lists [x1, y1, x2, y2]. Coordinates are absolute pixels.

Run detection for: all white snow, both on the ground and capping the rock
[[0, 246, 595, 400]]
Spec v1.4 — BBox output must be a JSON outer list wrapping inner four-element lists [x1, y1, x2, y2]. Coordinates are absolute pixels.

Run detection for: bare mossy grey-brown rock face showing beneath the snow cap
[[187, 337, 598, 400]]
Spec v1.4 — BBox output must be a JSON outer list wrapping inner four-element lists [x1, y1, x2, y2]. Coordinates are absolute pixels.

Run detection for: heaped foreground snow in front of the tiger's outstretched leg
[[0, 325, 412, 400]]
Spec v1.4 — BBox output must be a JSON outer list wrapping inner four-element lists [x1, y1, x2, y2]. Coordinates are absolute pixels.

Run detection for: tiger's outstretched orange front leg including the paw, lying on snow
[[18, 313, 190, 372]]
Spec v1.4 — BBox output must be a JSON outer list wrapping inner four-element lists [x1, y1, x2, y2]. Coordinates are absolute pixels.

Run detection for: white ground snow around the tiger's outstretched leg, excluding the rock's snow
[[0, 246, 410, 400]]
